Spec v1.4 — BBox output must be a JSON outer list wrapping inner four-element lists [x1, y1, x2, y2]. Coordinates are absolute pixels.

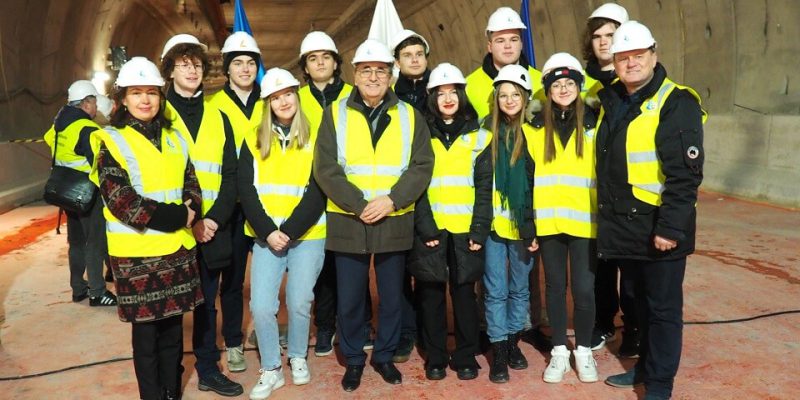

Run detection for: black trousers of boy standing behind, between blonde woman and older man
[[314, 250, 372, 332]]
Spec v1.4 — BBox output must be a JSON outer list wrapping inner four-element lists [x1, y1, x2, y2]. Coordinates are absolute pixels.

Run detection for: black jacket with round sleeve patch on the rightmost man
[[596, 64, 704, 260]]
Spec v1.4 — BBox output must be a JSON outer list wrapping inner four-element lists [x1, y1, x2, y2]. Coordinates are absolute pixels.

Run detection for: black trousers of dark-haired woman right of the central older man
[[415, 235, 480, 369]]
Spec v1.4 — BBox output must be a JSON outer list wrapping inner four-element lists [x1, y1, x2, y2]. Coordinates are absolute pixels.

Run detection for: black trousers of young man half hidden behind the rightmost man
[[594, 260, 639, 332]]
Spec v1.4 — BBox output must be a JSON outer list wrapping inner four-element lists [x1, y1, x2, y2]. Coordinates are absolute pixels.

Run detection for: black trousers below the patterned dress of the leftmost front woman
[[131, 315, 183, 400]]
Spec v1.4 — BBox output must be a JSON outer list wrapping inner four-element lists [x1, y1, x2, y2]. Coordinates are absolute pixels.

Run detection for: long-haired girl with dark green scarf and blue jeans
[[483, 64, 538, 383]]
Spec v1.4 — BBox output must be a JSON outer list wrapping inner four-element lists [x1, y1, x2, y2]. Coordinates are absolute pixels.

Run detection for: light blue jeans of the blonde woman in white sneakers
[[250, 239, 325, 370]]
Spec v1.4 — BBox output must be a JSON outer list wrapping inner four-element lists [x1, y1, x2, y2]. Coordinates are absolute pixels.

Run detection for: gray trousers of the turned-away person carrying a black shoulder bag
[[65, 194, 108, 297]]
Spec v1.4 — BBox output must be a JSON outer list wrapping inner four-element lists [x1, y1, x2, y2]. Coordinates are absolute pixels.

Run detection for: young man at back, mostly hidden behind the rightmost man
[[583, 3, 639, 358]]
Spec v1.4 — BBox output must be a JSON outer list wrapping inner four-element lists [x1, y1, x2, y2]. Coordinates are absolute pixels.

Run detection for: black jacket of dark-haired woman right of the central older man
[[407, 120, 494, 284]]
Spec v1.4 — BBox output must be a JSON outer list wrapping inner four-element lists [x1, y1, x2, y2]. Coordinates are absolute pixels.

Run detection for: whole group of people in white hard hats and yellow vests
[[47, 3, 705, 399]]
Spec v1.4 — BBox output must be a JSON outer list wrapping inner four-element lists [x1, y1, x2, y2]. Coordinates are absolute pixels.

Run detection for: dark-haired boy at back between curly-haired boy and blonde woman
[[208, 32, 264, 372]]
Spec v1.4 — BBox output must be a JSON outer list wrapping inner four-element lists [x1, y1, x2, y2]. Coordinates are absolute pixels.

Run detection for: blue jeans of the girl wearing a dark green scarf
[[483, 235, 534, 343]]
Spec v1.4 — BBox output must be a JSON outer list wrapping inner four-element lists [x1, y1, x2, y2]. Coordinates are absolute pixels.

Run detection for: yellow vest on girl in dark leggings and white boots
[[528, 120, 597, 238]]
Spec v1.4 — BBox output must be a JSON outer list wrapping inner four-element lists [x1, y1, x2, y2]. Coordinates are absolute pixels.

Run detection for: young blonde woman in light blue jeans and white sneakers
[[239, 68, 326, 399]]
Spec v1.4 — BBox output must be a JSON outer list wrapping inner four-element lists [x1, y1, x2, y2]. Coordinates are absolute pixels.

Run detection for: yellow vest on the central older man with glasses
[[327, 98, 415, 216]]
